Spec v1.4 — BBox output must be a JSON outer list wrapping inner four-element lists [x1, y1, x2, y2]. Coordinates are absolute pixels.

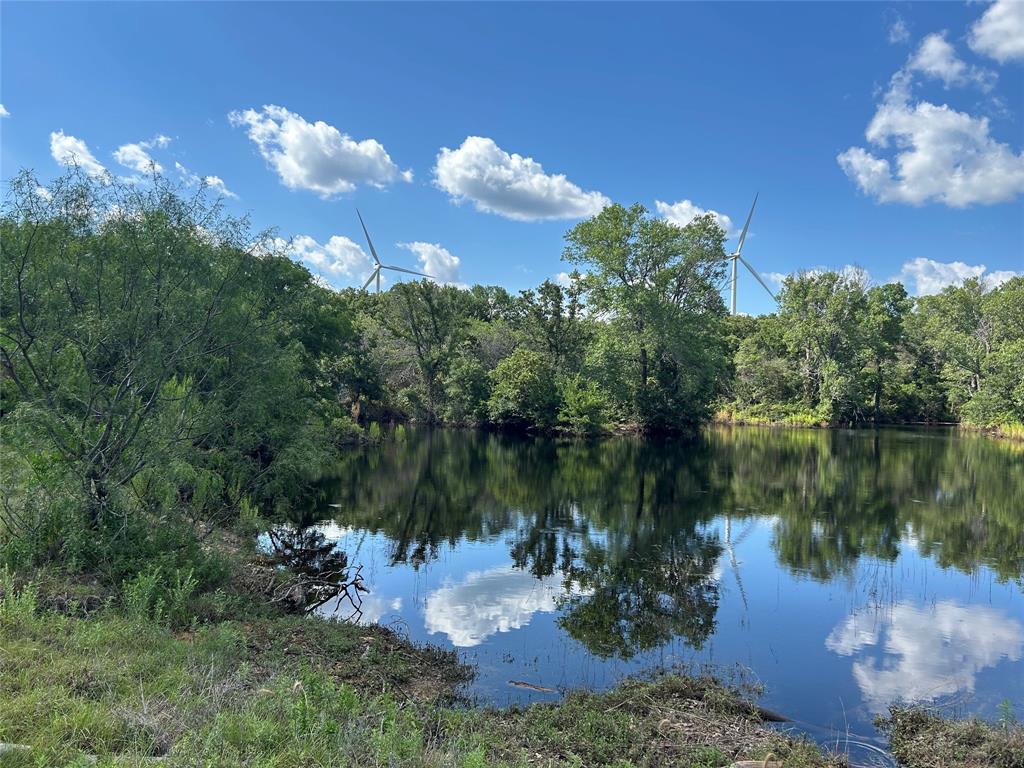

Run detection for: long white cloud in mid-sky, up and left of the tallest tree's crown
[[434, 136, 611, 221]]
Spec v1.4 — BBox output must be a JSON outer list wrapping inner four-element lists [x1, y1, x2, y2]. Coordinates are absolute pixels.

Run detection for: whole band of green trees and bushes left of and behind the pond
[[0, 167, 1024, 564]]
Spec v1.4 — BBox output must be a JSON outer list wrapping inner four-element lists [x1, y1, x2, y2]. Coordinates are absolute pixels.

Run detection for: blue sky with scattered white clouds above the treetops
[[0, 0, 1024, 313]]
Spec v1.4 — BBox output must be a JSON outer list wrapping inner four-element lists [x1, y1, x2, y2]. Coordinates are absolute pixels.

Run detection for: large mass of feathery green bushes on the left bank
[[0, 174, 358, 575]]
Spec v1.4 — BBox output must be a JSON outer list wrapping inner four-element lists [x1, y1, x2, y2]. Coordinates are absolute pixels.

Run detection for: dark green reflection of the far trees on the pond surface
[[290, 428, 1024, 658]]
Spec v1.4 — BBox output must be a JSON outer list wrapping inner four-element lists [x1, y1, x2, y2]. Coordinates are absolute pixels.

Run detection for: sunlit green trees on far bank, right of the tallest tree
[[727, 271, 1024, 429]]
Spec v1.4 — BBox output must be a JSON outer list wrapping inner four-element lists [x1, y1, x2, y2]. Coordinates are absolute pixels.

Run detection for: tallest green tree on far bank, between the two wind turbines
[[563, 204, 725, 429]]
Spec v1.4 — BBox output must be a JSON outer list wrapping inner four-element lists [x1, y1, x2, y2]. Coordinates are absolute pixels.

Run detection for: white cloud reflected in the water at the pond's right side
[[825, 601, 1024, 713]]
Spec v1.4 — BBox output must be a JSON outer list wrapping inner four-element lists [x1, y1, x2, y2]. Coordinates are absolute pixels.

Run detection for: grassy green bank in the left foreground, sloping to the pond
[[0, 561, 842, 768]]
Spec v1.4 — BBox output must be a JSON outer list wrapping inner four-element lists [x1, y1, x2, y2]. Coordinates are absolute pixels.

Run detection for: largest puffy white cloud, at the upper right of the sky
[[837, 70, 1024, 208]]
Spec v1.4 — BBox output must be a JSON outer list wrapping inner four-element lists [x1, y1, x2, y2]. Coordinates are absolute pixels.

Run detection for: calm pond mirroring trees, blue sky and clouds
[[282, 427, 1024, 763]]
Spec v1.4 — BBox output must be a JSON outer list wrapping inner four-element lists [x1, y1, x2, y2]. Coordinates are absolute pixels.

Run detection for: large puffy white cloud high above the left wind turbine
[[227, 104, 413, 198]]
